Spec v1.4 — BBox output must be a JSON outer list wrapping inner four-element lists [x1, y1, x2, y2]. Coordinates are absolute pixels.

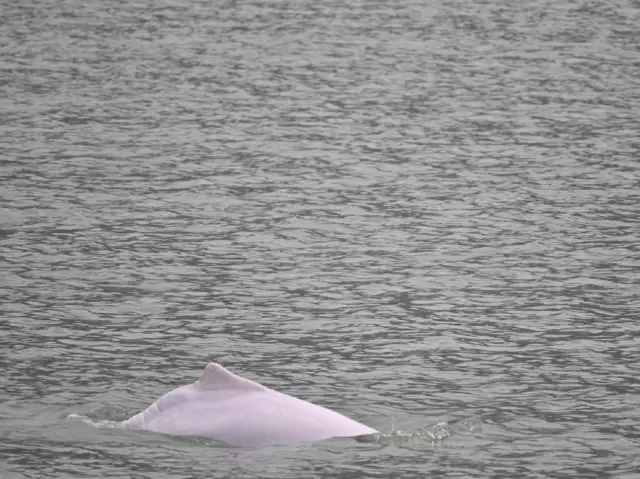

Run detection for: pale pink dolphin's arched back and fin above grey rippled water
[[123, 363, 378, 446]]
